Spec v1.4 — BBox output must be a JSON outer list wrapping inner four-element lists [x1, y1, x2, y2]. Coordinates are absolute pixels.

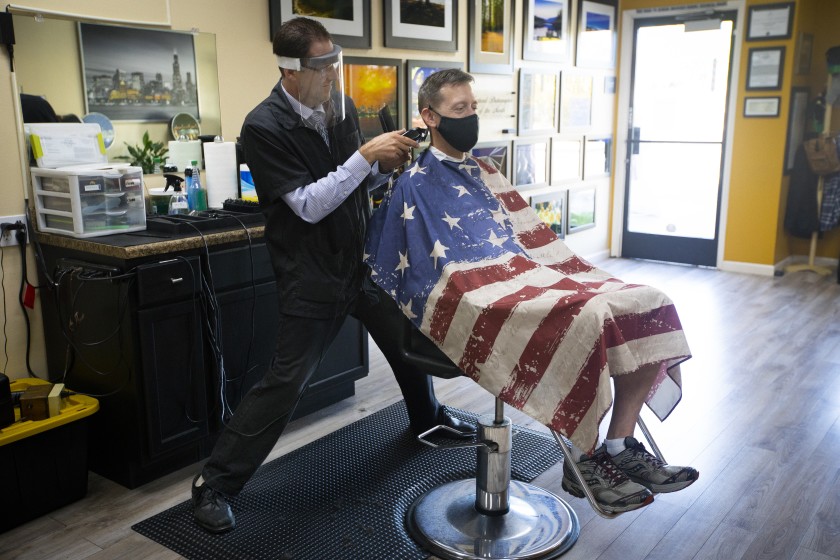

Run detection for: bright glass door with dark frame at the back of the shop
[[621, 12, 735, 266]]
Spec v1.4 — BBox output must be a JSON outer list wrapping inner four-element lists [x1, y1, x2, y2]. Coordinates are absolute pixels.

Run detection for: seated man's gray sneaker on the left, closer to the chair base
[[563, 446, 653, 513]]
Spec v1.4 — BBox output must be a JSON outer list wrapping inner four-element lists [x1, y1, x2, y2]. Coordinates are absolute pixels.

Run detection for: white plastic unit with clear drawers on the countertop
[[31, 164, 146, 237]]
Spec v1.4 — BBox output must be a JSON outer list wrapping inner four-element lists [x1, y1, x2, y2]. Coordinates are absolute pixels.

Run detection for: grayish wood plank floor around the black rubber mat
[[0, 259, 840, 560]]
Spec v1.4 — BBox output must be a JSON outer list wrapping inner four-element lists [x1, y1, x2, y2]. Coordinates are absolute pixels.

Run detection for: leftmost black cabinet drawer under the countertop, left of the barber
[[137, 257, 201, 307]]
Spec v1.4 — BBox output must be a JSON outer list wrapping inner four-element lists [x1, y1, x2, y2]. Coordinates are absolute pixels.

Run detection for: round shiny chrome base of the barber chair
[[406, 478, 580, 560]]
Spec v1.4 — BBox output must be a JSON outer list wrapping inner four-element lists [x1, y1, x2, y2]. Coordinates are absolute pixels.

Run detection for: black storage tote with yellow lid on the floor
[[0, 379, 99, 532]]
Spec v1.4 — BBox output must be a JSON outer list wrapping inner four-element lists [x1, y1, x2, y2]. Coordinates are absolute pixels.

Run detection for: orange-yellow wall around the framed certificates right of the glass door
[[619, 0, 840, 265]]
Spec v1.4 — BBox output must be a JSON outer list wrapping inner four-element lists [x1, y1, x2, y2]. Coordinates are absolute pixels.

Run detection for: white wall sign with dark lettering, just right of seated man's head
[[472, 73, 516, 140]]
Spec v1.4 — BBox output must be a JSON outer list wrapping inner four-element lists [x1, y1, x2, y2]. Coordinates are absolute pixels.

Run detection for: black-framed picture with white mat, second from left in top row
[[383, 0, 458, 52]]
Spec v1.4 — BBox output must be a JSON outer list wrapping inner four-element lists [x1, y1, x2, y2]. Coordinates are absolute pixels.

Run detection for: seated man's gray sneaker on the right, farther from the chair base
[[612, 437, 700, 493]]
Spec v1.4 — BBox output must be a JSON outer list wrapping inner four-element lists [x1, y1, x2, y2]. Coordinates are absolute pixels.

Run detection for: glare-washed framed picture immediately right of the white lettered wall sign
[[517, 68, 558, 136]]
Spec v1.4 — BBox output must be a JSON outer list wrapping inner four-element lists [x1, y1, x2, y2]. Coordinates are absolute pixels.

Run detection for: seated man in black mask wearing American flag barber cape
[[366, 70, 698, 512]]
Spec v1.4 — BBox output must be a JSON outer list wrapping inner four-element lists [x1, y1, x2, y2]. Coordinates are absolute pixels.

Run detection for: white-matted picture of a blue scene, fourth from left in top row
[[522, 0, 572, 64]]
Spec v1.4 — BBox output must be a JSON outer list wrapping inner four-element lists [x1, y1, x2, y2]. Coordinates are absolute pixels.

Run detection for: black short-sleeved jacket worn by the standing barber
[[241, 82, 370, 318]]
